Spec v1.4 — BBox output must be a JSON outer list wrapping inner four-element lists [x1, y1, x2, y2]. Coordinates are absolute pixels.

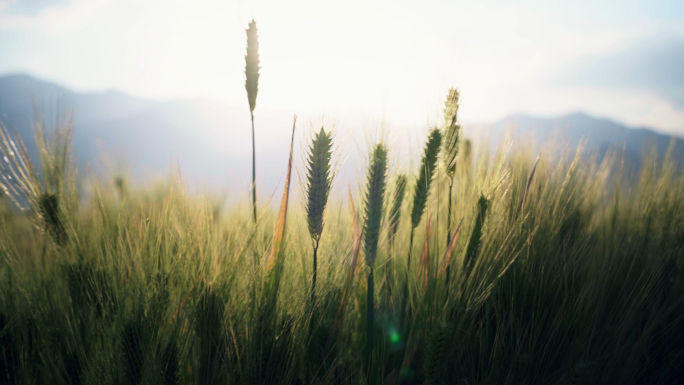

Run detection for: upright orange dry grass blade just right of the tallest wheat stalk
[[268, 115, 297, 294]]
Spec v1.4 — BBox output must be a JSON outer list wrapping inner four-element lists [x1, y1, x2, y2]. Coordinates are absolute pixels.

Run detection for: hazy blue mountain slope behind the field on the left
[[0, 75, 292, 192]]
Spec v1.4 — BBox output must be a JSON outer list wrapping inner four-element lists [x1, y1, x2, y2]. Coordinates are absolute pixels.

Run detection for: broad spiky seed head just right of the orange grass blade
[[306, 127, 332, 245]]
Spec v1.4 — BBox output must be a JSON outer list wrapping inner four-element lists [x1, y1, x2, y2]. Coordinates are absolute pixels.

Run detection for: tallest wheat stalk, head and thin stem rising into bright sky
[[245, 19, 259, 223]]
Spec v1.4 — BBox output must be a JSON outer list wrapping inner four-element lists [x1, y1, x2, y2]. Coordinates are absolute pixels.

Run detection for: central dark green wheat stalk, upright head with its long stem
[[363, 144, 387, 385]]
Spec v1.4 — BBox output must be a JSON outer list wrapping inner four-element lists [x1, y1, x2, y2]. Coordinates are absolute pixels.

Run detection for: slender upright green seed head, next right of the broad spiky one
[[363, 143, 387, 266]]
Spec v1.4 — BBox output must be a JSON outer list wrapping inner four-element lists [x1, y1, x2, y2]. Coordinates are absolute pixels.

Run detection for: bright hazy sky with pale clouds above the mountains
[[0, 0, 684, 134]]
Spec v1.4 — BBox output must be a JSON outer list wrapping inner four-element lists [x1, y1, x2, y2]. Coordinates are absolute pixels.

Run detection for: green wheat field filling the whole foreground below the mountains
[[0, 21, 684, 385]]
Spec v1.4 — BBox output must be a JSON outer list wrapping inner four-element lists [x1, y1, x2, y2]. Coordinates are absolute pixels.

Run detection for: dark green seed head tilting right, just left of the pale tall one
[[411, 128, 442, 228]]
